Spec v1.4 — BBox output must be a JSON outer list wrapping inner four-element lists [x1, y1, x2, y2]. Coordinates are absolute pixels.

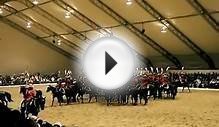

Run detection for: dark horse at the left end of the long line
[[46, 85, 64, 106]]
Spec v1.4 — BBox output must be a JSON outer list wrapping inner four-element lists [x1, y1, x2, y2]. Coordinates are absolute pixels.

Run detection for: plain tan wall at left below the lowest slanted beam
[[0, 22, 78, 74]]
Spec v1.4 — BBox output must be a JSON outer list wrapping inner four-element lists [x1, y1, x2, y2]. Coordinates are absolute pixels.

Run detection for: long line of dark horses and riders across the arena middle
[[46, 76, 177, 106]]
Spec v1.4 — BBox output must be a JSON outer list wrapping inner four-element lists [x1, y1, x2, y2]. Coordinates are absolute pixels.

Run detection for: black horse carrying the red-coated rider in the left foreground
[[20, 86, 46, 118]]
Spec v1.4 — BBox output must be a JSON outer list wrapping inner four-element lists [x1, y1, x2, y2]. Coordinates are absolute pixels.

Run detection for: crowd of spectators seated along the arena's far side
[[0, 68, 219, 89]]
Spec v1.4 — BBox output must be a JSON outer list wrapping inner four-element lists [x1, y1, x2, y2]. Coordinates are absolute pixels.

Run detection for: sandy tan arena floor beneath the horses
[[0, 86, 219, 127]]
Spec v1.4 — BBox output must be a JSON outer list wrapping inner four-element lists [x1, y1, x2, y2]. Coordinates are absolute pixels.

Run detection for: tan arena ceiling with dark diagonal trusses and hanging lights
[[0, 0, 219, 69]]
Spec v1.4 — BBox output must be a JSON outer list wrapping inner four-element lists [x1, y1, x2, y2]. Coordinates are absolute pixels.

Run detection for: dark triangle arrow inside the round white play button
[[105, 52, 117, 75]]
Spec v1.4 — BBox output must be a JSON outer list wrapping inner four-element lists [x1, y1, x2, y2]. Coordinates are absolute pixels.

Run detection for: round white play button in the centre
[[83, 37, 135, 89]]
